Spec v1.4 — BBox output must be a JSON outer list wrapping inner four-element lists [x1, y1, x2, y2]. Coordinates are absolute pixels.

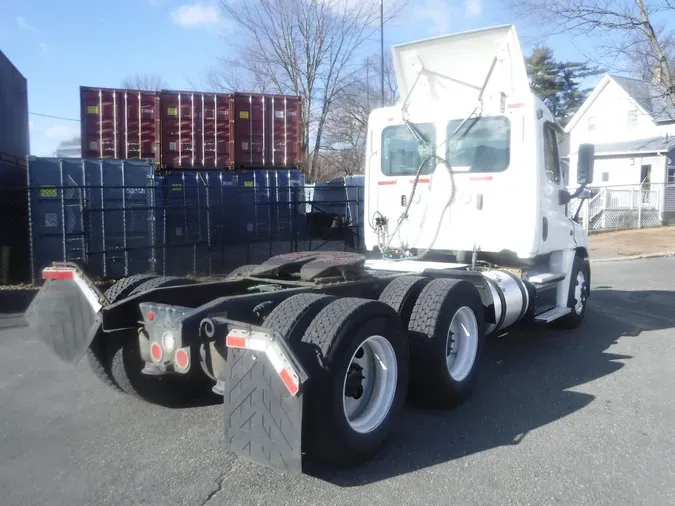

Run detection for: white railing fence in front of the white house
[[568, 184, 675, 232]]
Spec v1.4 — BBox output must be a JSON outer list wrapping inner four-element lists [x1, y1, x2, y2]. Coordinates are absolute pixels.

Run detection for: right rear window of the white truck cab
[[446, 116, 511, 172]]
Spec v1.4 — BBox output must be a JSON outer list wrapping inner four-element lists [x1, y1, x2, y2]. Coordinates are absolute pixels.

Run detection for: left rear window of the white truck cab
[[382, 123, 436, 176]]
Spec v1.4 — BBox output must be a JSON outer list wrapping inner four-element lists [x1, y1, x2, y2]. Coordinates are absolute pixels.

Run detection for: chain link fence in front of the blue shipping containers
[[17, 180, 363, 282]]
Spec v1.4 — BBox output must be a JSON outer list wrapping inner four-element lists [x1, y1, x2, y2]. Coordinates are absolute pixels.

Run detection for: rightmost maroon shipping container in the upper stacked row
[[234, 93, 302, 168]]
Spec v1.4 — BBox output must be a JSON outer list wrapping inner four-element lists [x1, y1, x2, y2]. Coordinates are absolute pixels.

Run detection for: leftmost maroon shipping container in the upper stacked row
[[80, 87, 160, 158]]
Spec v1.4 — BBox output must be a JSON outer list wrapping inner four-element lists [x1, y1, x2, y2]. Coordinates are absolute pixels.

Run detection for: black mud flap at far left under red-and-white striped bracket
[[25, 279, 99, 364]]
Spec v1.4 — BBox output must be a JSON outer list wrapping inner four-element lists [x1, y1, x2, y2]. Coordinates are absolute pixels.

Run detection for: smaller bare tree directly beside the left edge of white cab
[[321, 57, 398, 176]]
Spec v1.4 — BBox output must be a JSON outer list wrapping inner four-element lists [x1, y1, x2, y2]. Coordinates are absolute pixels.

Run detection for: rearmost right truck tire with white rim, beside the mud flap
[[299, 298, 409, 467]]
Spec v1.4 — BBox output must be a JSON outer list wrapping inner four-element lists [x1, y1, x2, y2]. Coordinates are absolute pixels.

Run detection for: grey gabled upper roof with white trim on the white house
[[565, 74, 675, 133]]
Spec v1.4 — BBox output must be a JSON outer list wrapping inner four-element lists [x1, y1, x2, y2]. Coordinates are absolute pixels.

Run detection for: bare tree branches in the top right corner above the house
[[511, 0, 675, 111]]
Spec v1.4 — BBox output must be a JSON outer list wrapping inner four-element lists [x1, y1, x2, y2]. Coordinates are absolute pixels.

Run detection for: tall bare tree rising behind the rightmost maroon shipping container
[[221, 0, 404, 180]]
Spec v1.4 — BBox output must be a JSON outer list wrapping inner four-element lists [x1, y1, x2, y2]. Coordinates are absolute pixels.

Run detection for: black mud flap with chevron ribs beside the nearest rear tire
[[224, 349, 302, 474]]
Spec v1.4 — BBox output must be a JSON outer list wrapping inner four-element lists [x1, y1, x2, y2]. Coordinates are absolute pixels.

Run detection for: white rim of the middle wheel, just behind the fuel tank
[[445, 306, 478, 381]]
